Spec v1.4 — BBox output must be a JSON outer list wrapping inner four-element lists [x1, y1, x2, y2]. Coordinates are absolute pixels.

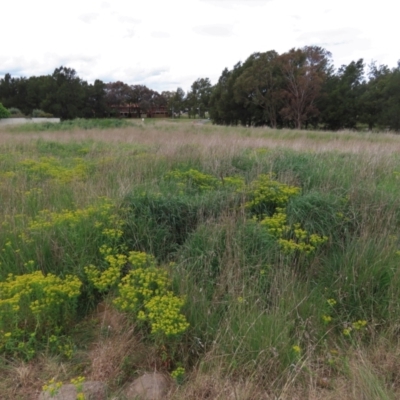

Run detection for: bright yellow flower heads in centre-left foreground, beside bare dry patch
[[85, 251, 189, 342]]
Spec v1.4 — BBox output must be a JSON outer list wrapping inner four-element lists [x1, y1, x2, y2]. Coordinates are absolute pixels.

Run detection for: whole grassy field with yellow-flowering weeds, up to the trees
[[0, 120, 400, 400]]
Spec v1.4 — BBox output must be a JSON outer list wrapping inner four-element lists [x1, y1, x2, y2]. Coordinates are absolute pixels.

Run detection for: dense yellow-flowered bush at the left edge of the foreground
[[0, 271, 82, 359]]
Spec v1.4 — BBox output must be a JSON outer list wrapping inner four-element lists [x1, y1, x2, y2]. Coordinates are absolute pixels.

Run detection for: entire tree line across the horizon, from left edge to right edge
[[0, 46, 400, 131]]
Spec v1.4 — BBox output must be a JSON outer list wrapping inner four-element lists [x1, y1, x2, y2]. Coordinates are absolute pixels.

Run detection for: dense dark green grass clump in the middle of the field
[[124, 178, 240, 261]]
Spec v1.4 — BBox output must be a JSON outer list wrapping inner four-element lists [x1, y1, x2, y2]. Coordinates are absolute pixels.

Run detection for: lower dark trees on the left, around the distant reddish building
[[0, 66, 171, 120]]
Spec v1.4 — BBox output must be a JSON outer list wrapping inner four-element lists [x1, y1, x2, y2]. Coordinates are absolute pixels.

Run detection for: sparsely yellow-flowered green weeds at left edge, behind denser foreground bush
[[0, 198, 123, 279]]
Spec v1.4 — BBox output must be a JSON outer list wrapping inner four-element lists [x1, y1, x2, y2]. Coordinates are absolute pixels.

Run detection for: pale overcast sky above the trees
[[0, 0, 400, 92]]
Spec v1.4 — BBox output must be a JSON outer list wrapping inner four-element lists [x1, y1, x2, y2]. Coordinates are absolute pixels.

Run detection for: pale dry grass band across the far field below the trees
[[0, 121, 400, 156]]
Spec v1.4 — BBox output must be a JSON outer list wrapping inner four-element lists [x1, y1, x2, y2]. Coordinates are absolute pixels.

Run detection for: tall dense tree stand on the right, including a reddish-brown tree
[[209, 46, 400, 131]]
